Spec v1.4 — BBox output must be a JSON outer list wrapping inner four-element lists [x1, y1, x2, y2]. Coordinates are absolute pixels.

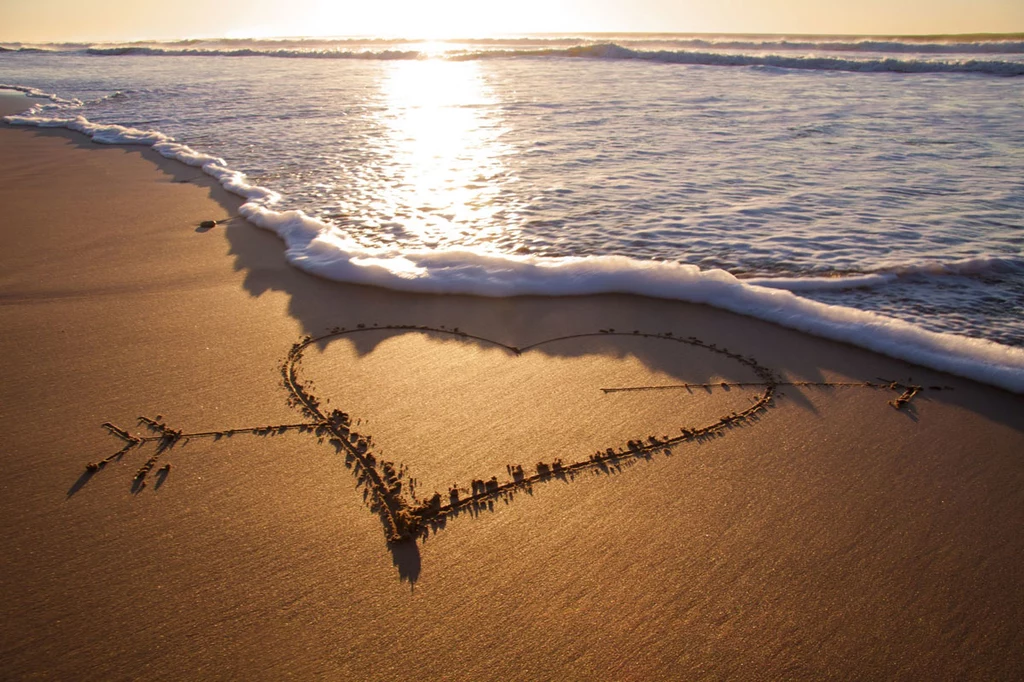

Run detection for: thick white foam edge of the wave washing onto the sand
[[5, 107, 1024, 393]]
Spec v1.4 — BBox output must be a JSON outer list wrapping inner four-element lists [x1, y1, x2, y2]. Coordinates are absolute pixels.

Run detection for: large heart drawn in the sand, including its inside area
[[282, 327, 777, 542]]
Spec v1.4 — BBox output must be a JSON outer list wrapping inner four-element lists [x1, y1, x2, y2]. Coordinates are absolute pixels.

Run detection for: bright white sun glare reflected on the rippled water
[[364, 59, 517, 248]]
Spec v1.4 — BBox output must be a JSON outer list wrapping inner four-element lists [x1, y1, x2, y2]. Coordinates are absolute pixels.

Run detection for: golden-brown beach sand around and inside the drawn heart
[[0, 97, 1024, 680]]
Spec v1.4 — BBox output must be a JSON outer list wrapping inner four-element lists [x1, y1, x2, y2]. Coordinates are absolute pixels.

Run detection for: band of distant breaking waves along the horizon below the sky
[[0, 35, 1024, 76]]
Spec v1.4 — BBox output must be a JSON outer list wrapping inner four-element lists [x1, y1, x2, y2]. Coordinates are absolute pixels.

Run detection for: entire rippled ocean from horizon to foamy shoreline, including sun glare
[[6, 35, 1024, 390]]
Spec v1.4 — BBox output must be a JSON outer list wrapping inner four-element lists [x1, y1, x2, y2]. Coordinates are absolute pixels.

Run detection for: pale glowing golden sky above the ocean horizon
[[0, 0, 1024, 42]]
